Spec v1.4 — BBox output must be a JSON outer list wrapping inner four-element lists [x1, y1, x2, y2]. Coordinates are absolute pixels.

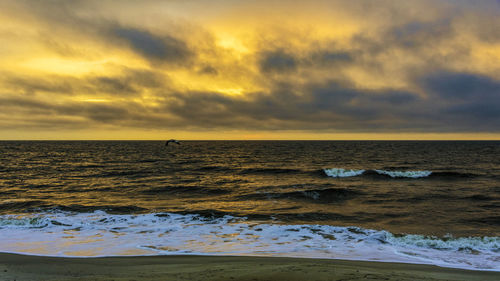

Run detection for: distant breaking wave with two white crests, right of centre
[[323, 168, 476, 179]]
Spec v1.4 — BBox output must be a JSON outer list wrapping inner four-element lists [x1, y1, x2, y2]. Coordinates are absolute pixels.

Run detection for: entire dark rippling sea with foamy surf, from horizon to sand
[[0, 141, 500, 271]]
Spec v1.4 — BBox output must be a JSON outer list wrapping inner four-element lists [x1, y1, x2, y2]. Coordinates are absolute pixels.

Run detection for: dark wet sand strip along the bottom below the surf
[[0, 254, 500, 281]]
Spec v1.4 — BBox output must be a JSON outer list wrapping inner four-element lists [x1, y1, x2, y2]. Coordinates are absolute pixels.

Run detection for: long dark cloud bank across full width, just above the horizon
[[0, 71, 500, 132]]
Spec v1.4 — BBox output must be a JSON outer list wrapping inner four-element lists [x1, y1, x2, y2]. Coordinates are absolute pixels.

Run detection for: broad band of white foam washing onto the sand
[[0, 211, 500, 271]]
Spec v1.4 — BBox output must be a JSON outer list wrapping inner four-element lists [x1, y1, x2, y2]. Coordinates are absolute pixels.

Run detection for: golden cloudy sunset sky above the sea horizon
[[0, 0, 500, 140]]
